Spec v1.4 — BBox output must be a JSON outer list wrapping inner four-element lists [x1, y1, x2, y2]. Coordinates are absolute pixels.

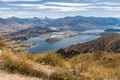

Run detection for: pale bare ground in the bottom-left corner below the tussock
[[0, 71, 42, 80]]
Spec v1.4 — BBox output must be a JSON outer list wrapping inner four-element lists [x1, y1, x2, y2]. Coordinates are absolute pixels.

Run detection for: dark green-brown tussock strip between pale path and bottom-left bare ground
[[0, 56, 47, 77]]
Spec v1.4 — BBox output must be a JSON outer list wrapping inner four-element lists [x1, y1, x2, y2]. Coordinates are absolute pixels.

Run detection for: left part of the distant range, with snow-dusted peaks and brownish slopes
[[0, 17, 51, 33]]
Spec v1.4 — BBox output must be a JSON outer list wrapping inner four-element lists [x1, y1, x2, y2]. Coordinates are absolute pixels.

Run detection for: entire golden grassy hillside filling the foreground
[[0, 42, 120, 80]]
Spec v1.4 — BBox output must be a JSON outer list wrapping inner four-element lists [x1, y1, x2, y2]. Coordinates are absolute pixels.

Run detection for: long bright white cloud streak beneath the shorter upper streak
[[8, 3, 92, 12]]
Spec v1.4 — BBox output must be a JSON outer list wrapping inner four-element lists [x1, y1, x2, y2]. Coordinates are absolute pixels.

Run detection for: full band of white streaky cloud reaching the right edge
[[7, 2, 120, 12]]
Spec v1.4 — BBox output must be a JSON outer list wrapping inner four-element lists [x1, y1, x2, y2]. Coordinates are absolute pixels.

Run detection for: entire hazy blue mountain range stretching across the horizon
[[0, 16, 120, 33]]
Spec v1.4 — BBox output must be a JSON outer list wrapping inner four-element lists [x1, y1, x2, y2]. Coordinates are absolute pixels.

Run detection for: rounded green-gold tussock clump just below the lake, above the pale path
[[35, 53, 65, 66]]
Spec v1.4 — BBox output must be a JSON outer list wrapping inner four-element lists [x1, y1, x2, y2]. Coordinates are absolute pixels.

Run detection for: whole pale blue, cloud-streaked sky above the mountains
[[0, 0, 120, 18]]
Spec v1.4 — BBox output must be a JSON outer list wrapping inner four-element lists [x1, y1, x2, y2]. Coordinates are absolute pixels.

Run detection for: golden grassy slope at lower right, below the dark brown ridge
[[69, 51, 120, 80]]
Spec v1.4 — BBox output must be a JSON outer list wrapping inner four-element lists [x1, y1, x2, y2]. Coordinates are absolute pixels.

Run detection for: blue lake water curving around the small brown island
[[25, 35, 100, 53]]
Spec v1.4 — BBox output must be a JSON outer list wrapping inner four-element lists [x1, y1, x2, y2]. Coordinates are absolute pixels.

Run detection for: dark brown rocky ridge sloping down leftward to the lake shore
[[57, 34, 120, 57]]
